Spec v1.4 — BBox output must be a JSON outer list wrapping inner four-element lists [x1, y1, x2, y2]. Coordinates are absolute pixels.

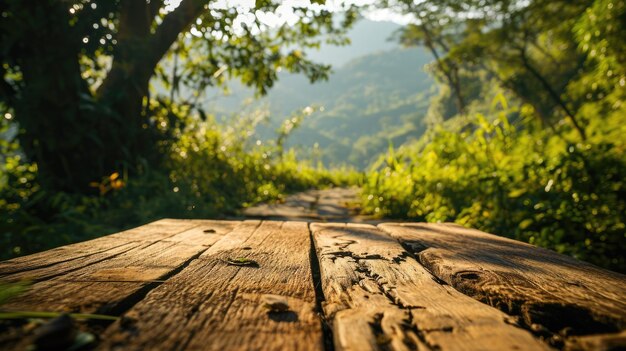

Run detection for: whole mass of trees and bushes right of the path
[[356, 0, 626, 272]]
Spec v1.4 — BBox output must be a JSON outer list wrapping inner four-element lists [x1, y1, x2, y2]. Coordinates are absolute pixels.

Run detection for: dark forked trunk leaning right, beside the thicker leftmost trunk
[[91, 0, 208, 176]]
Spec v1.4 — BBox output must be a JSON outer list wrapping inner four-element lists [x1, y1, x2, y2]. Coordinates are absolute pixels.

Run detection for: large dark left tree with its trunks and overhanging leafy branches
[[0, 0, 355, 193]]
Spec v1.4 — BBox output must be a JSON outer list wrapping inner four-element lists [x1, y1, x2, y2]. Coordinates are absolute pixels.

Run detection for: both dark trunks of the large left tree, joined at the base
[[15, 0, 207, 194]]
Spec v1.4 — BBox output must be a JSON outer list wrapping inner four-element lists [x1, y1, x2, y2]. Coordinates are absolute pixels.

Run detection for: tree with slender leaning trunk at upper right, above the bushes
[[382, 0, 591, 140]]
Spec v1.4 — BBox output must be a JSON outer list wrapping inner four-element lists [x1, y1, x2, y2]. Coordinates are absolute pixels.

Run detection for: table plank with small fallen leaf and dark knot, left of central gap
[[99, 221, 322, 350]]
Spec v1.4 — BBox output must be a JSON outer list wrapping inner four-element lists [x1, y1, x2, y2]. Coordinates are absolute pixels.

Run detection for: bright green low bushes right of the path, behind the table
[[363, 98, 626, 271]]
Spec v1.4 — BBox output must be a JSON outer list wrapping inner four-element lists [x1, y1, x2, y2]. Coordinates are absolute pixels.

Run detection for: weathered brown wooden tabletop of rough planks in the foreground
[[0, 219, 626, 351]]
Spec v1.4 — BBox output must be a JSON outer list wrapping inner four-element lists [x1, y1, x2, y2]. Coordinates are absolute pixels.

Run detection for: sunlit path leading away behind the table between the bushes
[[243, 187, 371, 222]]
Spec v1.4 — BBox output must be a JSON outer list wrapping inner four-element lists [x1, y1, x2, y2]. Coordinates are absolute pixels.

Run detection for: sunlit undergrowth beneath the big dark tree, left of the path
[[0, 101, 358, 258]]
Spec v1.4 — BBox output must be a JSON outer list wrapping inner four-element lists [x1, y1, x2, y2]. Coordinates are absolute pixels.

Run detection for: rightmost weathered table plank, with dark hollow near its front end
[[379, 224, 626, 346]]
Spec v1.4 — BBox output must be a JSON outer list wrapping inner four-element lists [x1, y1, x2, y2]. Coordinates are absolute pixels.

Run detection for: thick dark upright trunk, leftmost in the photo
[[14, 1, 102, 192]]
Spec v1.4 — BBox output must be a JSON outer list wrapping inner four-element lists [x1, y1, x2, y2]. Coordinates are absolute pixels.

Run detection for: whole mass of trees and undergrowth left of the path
[[0, 0, 356, 257]]
